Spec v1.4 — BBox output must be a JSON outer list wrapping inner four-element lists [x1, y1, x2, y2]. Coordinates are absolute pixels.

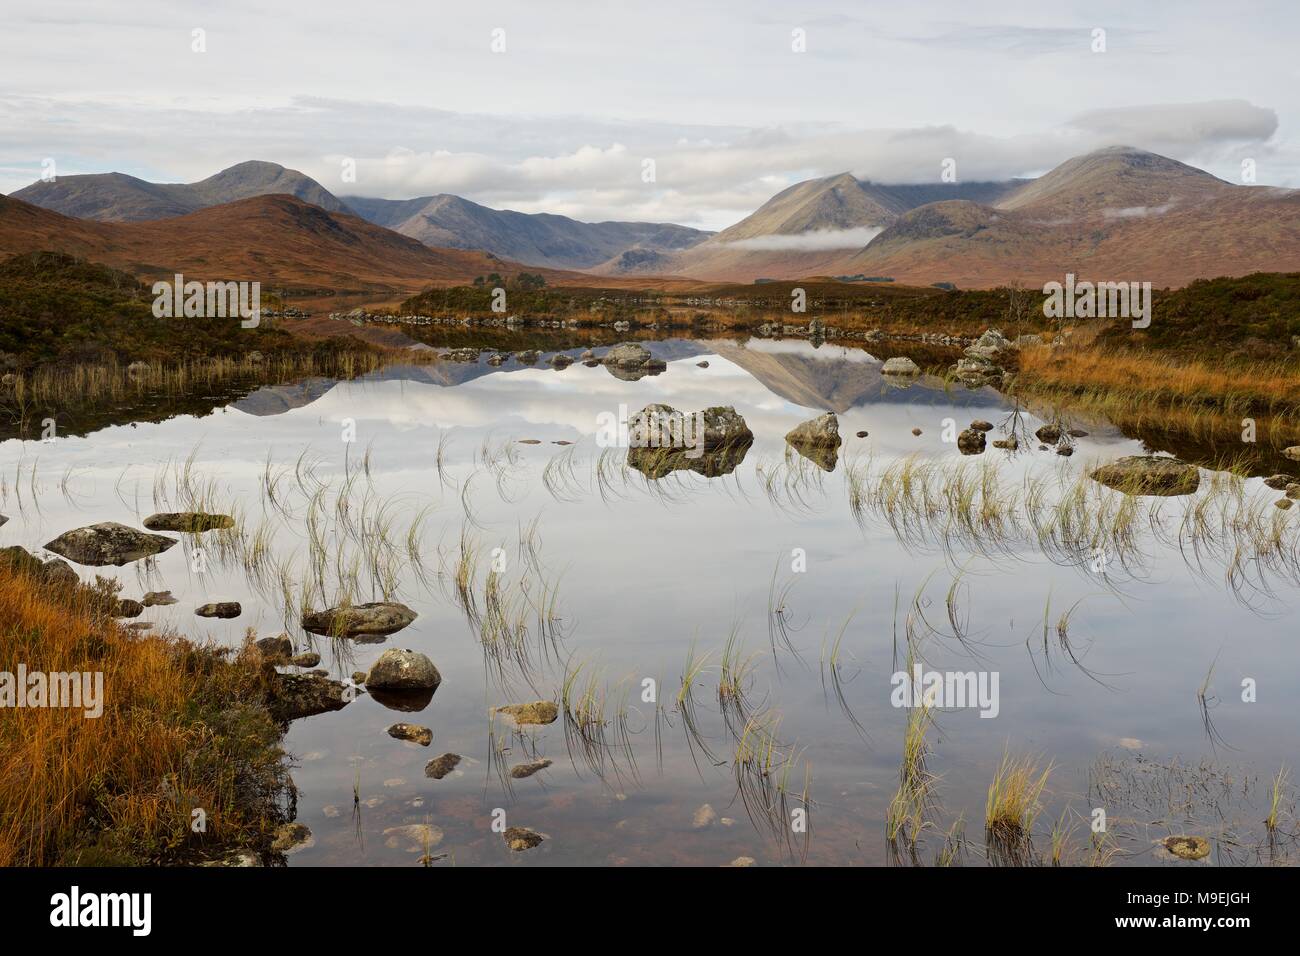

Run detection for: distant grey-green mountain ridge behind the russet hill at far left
[[10, 161, 351, 222]]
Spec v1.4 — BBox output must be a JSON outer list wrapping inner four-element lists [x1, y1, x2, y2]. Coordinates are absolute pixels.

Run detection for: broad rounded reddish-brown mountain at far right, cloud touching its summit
[[840, 147, 1300, 287]]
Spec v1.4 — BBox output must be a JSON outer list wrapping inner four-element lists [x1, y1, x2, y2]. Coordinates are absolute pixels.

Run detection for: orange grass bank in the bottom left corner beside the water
[[0, 567, 287, 866]]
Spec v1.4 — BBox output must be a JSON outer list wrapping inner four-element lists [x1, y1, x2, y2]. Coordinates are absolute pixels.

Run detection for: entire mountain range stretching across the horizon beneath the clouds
[[0, 146, 1300, 290]]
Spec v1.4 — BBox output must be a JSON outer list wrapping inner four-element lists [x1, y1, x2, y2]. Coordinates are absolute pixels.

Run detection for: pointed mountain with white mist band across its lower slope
[[650, 173, 1023, 282]]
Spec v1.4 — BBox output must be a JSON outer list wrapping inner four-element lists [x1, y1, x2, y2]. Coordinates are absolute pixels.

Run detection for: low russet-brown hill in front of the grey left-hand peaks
[[0, 195, 517, 293]]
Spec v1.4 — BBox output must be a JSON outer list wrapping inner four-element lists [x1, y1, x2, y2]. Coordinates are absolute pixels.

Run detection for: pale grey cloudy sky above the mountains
[[0, 0, 1300, 228]]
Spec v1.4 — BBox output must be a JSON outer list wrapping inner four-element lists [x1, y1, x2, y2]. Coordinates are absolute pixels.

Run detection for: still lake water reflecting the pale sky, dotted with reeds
[[0, 339, 1300, 866]]
